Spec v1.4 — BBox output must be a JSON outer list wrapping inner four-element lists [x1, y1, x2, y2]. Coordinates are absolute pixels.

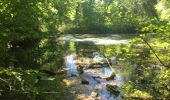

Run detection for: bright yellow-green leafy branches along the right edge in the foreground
[[119, 10, 170, 99]]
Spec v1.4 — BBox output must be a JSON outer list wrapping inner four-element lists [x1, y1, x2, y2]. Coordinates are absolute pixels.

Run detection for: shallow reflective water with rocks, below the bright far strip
[[62, 36, 130, 100]]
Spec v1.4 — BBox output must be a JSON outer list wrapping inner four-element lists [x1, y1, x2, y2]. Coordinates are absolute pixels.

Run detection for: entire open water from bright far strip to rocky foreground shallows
[[62, 35, 133, 100]]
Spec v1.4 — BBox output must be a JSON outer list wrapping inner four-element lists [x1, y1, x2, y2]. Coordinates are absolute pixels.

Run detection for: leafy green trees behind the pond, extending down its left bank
[[0, 0, 170, 73]]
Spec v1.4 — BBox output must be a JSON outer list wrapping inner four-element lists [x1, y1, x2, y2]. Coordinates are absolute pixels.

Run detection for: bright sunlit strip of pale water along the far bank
[[59, 34, 133, 45]]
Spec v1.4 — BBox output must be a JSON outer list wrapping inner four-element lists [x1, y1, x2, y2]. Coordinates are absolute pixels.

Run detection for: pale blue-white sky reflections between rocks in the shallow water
[[65, 54, 122, 100]]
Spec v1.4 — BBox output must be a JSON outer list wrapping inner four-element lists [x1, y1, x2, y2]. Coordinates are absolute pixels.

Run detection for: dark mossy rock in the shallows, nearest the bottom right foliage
[[106, 84, 120, 96]]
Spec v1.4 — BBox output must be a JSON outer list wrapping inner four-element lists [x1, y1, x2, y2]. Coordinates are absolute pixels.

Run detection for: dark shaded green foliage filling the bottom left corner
[[0, 68, 68, 100]]
